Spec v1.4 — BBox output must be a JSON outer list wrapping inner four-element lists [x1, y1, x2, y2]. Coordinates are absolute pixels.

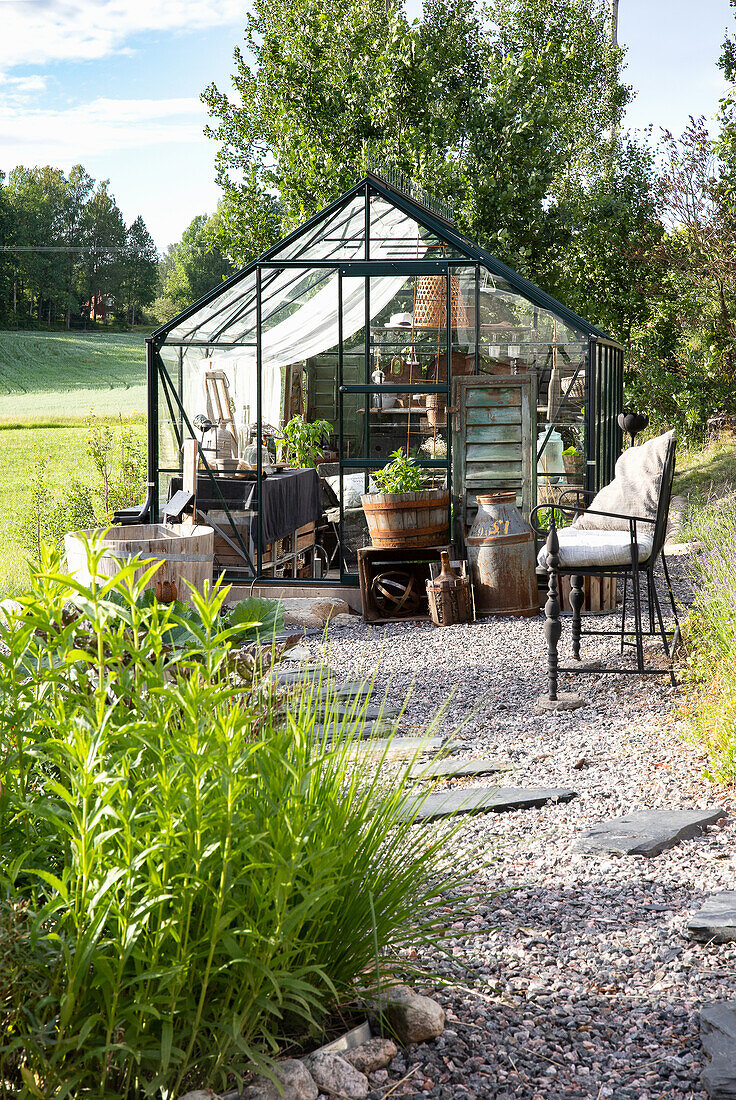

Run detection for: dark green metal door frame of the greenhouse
[[337, 260, 455, 585]]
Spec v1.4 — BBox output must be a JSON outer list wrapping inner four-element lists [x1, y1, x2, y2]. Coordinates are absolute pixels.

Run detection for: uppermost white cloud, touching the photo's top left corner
[[0, 0, 245, 70]]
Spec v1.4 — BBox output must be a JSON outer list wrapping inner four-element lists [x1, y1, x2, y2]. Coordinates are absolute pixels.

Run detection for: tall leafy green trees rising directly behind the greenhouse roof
[[204, 0, 628, 285]]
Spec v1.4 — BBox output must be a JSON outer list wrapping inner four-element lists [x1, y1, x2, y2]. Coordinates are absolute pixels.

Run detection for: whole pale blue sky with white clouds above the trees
[[0, 0, 736, 251]]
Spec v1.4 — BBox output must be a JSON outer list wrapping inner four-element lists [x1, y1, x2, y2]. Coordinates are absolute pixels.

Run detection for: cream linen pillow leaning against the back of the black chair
[[572, 431, 674, 532]]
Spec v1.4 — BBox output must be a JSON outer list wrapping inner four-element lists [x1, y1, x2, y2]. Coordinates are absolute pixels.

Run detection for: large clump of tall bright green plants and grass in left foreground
[[0, 548, 473, 1100]]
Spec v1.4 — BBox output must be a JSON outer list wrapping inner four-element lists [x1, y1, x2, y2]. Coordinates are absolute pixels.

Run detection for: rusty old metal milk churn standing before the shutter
[[466, 492, 539, 615]]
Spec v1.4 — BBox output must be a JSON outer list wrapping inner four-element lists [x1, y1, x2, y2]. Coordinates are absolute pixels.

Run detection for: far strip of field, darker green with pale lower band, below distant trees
[[0, 332, 145, 424]]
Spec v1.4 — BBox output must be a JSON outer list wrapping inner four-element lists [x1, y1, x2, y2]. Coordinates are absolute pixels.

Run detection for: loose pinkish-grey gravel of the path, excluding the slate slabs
[[301, 558, 736, 1100]]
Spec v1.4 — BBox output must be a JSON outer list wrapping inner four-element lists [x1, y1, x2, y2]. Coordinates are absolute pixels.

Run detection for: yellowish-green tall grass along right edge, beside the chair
[[684, 493, 736, 783]]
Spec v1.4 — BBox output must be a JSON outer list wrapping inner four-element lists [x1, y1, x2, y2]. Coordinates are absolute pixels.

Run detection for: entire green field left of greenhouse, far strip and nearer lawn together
[[0, 332, 146, 596]]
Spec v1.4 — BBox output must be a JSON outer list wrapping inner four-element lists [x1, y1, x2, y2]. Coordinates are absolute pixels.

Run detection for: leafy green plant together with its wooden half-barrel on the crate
[[361, 448, 450, 549]]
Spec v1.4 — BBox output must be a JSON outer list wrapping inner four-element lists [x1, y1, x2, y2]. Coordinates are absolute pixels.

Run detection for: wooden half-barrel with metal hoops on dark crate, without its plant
[[361, 488, 450, 550]]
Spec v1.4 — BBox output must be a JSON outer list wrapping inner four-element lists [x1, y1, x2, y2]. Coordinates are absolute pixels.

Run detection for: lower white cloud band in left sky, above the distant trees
[[0, 97, 207, 160]]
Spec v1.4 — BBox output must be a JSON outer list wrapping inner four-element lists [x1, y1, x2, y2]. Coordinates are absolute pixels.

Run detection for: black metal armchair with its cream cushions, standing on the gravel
[[531, 431, 680, 702]]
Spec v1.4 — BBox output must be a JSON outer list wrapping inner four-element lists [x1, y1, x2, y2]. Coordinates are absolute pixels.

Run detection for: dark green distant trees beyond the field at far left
[[0, 165, 158, 329]]
